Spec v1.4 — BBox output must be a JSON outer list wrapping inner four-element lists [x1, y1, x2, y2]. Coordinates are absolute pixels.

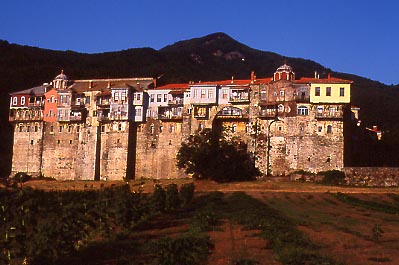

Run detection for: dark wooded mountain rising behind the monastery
[[0, 33, 399, 175]]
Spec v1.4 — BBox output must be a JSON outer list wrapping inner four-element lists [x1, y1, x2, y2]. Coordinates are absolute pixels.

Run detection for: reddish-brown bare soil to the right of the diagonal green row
[[251, 192, 399, 265]]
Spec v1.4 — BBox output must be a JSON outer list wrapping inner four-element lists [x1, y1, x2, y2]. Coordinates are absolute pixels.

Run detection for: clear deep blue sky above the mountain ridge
[[0, 0, 399, 84]]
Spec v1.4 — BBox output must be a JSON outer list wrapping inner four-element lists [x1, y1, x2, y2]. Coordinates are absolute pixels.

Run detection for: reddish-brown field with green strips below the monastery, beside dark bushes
[[3, 179, 399, 265]]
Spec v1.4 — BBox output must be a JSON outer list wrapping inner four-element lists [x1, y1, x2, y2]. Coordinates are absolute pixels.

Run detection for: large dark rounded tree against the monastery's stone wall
[[177, 129, 259, 182]]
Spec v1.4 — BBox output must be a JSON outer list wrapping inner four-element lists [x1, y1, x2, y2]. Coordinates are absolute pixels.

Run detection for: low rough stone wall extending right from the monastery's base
[[343, 167, 399, 187]]
